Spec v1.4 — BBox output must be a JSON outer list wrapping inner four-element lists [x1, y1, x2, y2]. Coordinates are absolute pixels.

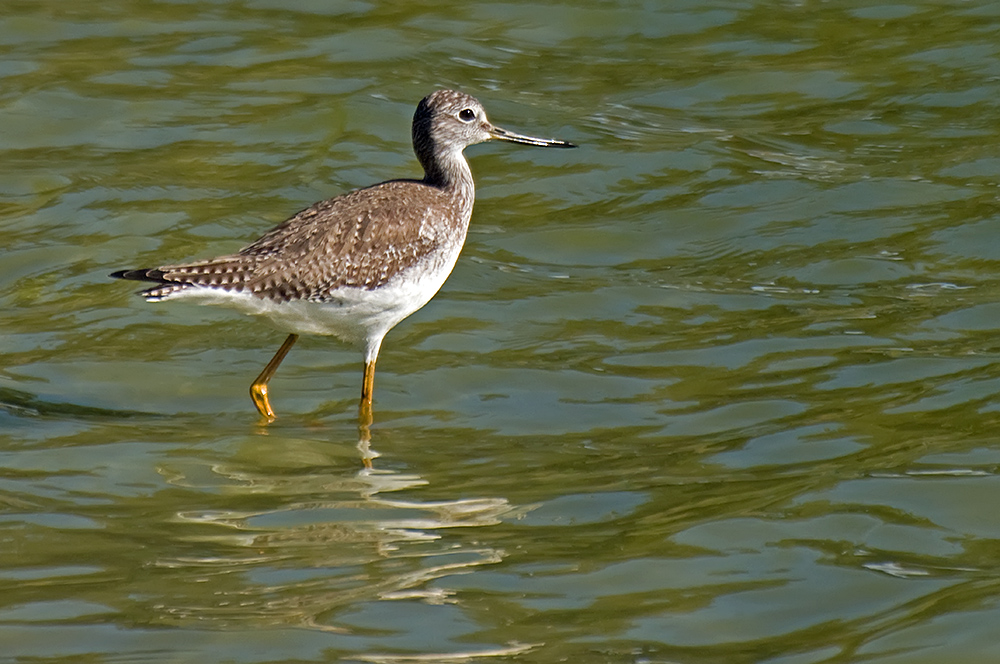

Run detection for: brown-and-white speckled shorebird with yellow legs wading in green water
[[111, 90, 576, 422]]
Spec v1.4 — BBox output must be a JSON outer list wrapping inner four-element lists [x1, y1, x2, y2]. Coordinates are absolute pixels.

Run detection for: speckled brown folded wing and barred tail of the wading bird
[[114, 180, 461, 302]]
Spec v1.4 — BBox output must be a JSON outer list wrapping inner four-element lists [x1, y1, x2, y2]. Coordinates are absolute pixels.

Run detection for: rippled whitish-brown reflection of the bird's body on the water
[[155, 454, 517, 631]]
